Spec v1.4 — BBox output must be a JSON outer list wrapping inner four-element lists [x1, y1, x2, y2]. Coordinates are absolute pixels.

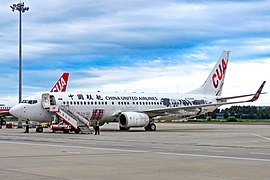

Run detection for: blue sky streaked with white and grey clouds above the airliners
[[0, 0, 270, 105]]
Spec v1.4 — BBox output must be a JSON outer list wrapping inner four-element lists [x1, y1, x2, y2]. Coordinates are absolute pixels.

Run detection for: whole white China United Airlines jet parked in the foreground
[[10, 50, 265, 133]]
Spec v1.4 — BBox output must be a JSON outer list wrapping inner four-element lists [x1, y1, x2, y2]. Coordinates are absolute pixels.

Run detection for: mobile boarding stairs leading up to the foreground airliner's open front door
[[50, 106, 92, 134]]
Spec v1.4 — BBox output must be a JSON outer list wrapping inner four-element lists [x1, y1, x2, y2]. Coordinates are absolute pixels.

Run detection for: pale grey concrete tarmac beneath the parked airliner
[[0, 123, 270, 180]]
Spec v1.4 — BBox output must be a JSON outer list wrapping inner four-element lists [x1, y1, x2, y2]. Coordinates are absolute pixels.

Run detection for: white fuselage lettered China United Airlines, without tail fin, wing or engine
[[11, 92, 217, 124]]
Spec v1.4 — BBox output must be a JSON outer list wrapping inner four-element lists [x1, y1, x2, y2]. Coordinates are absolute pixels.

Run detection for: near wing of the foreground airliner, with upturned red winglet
[[143, 81, 266, 116]]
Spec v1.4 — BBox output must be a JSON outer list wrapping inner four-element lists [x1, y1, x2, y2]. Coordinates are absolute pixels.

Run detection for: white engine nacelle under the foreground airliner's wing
[[119, 112, 150, 128]]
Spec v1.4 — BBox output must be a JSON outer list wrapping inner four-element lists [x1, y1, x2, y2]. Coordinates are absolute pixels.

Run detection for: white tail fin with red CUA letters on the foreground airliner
[[188, 51, 230, 96]]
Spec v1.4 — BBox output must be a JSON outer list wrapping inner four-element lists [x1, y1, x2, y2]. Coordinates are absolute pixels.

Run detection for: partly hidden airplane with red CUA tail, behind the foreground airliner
[[0, 72, 69, 125]]
